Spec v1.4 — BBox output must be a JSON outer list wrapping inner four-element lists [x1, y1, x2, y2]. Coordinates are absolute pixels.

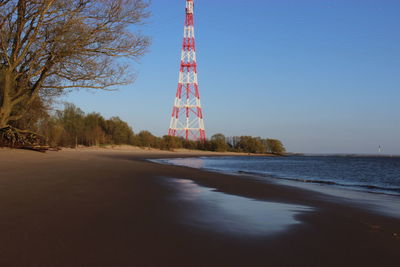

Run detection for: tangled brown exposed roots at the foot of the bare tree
[[0, 126, 48, 152]]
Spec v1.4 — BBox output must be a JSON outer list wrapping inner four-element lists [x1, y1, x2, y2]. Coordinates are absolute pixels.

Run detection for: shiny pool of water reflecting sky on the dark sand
[[167, 178, 312, 235]]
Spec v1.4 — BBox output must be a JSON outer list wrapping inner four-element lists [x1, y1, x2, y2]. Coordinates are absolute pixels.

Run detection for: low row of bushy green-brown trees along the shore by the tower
[[14, 103, 285, 154]]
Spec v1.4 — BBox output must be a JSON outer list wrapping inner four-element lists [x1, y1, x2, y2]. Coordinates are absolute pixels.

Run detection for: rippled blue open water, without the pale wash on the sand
[[154, 156, 400, 196]]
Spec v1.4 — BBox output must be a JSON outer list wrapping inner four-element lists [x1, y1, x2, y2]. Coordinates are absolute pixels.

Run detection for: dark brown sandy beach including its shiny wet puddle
[[0, 150, 400, 266]]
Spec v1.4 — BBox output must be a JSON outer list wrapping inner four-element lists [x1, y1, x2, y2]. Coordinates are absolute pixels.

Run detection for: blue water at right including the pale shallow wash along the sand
[[154, 156, 400, 219]]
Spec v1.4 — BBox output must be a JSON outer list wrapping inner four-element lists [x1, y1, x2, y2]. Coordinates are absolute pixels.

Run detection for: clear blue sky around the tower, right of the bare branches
[[63, 0, 400, 154]]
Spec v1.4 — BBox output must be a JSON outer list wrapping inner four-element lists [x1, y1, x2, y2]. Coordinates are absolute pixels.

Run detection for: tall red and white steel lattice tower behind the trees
[[168, 0, 206, 141]]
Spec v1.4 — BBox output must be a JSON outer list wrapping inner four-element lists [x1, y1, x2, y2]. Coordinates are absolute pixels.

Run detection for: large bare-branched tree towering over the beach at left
[[0, 0, 149, 129]]
